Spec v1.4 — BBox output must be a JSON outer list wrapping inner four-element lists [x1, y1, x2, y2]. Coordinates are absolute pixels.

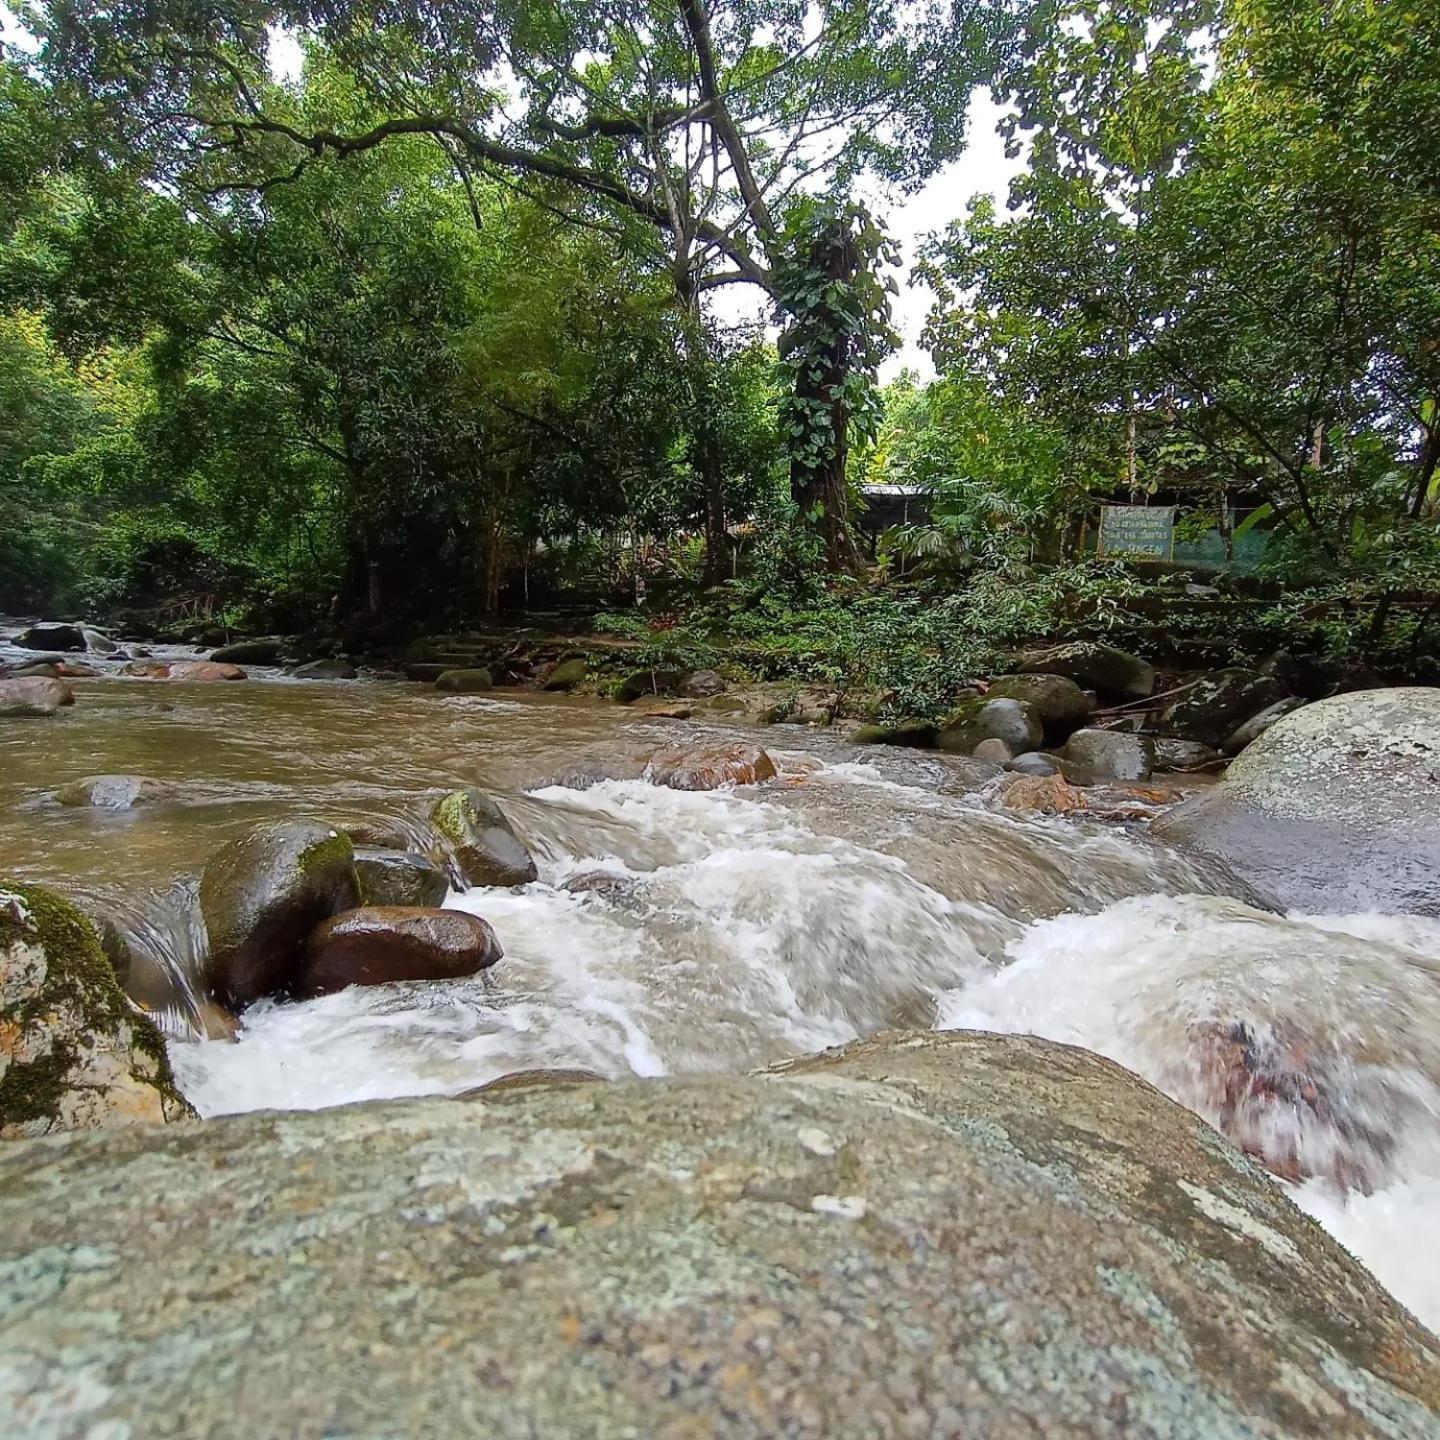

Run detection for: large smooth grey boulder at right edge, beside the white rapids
[[1153, 687, 1440, 914]]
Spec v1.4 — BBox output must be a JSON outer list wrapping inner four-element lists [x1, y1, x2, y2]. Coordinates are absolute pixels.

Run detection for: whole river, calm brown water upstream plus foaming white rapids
[[8, 636, 1440, 1325]]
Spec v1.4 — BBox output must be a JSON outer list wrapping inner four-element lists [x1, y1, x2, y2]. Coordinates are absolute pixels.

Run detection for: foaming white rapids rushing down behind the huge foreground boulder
[[171, 755, 1440, 1326]]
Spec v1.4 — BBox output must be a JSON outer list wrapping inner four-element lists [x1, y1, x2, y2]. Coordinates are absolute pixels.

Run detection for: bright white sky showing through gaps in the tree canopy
[[8, 15, 1020, 380]]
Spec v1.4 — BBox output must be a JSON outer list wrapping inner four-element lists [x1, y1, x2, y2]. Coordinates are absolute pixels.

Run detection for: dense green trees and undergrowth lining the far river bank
[[0, 0, 1440, 691]]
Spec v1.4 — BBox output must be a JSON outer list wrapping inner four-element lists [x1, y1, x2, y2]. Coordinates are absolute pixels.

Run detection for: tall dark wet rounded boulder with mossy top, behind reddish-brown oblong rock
[[200, 819, 360, 1009]]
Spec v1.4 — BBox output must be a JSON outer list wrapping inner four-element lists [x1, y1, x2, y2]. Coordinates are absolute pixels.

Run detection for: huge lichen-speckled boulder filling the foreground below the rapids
[[0, 1032, 1440, 1440]]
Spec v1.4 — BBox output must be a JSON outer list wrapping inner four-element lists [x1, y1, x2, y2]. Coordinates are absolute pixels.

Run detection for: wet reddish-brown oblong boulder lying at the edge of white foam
[[294, 906, 504, 995]]
